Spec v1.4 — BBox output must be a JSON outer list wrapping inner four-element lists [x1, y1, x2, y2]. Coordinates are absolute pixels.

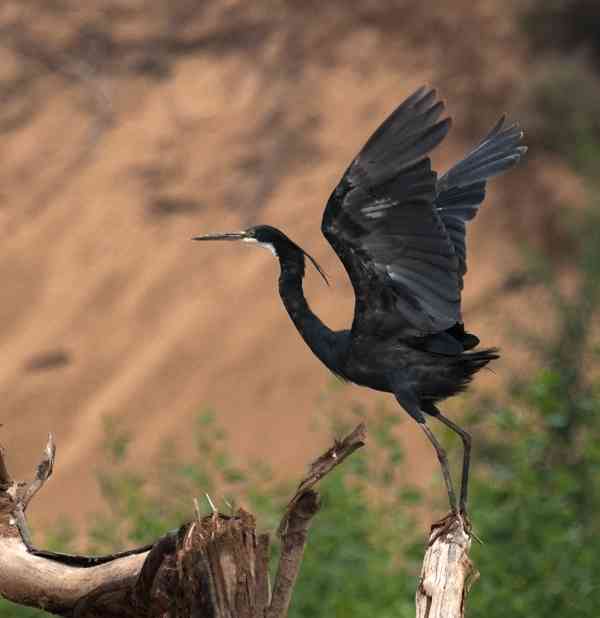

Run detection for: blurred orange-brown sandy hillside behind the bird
[[0, 0, 580, 526]]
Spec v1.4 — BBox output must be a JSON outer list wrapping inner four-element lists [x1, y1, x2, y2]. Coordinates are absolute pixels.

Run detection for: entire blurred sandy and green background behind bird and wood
[[0, 0, 600, 618]]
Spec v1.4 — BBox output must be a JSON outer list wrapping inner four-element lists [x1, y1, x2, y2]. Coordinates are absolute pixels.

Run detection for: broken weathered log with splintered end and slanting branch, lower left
[[0, 425, 365, 618]]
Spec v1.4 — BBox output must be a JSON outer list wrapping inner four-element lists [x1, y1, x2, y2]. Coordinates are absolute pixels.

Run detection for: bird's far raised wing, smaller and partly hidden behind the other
[[435, 116, 527, 289]]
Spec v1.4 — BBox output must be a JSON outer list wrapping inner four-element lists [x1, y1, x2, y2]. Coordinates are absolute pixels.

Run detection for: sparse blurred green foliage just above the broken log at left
[[90, 409, 274, 552]]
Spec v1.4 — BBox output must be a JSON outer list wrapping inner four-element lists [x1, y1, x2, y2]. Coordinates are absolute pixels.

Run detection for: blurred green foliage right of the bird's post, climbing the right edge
[[469, 196, 600, 618]]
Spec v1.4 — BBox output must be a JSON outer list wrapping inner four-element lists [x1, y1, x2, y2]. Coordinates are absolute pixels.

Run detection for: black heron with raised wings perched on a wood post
[[193, 86, 527, 516]]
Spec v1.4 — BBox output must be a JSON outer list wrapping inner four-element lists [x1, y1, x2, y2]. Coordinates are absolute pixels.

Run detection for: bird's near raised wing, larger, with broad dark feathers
[[321, 88, 460, 337]]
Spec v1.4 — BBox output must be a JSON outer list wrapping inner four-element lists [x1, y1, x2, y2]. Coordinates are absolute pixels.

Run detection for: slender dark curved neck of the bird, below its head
[[279, 256, 339, 373]]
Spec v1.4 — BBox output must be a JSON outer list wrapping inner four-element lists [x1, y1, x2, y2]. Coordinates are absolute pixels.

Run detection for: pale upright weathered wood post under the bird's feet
[[416, 514, 479, 618]]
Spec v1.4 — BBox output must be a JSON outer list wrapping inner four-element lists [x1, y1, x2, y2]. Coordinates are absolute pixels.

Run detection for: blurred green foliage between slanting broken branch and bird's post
[[290, 462, 416, 618]]
